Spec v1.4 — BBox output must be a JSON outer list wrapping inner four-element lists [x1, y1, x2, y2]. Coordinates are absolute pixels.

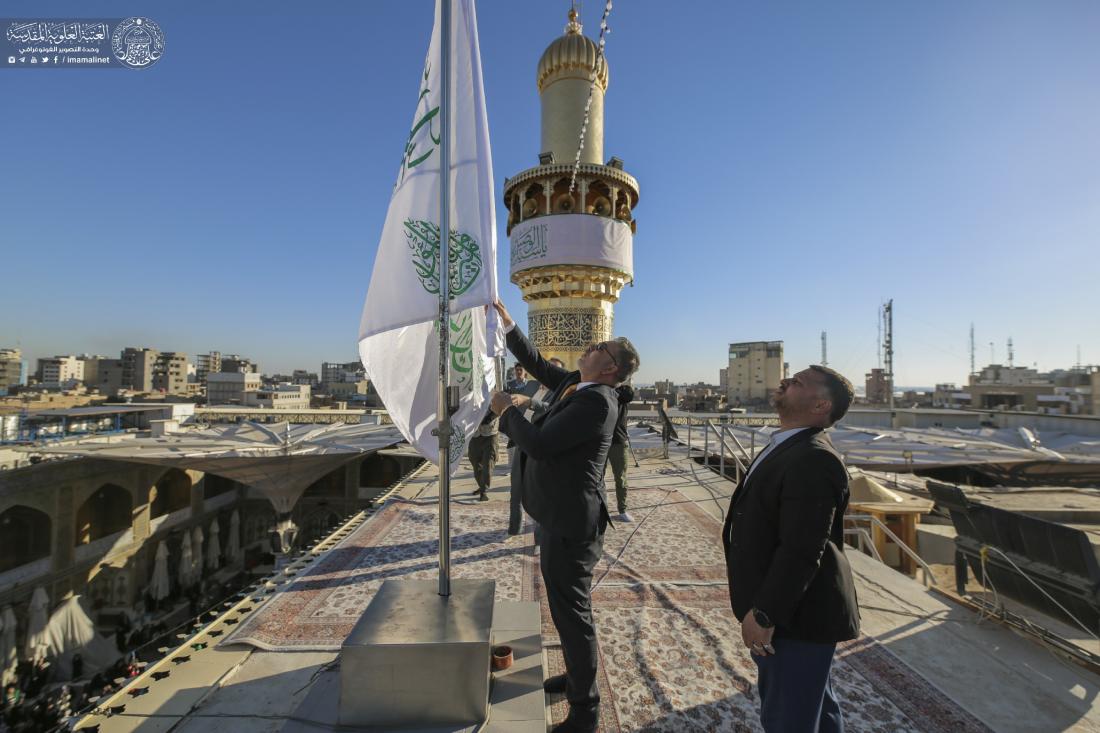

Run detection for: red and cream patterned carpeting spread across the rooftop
[[224, 479, 988, 733]]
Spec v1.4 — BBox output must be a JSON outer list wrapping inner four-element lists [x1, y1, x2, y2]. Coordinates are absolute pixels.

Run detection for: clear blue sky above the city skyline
[[0, 0, 1100, 384]]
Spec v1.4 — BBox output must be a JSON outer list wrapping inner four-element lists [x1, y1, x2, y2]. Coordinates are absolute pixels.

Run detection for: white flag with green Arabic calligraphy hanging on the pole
[[359, 0, 497, 472]]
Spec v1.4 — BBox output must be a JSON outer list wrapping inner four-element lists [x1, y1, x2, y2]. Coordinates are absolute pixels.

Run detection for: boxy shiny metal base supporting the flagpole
[[340, 580, 496, 730]]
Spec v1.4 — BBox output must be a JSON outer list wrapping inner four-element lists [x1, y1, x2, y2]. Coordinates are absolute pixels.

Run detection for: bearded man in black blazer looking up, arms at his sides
[[722, 365, 859, 733]]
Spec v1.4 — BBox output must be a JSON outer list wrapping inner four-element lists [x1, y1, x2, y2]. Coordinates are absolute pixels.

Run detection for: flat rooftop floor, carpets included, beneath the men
[[81, 431, 1100, 733]]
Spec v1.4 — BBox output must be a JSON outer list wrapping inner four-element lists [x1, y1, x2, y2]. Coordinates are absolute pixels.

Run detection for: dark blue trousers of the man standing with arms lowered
[[752, 638, 844, 733]]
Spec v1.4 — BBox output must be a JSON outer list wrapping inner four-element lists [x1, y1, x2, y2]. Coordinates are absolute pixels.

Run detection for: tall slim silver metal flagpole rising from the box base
[[438, 0, 453, 595]]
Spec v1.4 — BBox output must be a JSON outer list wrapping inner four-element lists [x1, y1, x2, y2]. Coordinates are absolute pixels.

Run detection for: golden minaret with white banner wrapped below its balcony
[[504, 10, 638, 369]]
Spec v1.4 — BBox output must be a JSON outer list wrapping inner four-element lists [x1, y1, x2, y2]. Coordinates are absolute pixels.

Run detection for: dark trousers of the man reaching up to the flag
[[539, 527, 604, 710]]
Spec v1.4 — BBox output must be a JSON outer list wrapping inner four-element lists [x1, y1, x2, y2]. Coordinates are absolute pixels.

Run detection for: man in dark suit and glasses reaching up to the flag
[[491, 303, 639, 733]]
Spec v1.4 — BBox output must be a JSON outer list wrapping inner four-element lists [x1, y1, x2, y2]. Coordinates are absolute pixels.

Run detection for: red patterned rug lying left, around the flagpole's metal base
[[222, 500, 532, 652]]
